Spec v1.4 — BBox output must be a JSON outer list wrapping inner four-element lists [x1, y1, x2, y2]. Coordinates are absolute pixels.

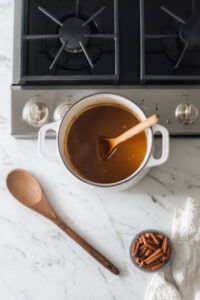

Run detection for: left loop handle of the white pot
[[38, 121, 60, 162]]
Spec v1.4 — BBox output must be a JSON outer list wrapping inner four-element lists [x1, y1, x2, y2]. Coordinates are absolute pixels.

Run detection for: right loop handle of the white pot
[[146, 124, 169, 168]]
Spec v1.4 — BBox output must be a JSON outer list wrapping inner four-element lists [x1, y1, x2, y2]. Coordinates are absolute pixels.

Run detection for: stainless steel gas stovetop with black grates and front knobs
[[11, 0, 200, 138]]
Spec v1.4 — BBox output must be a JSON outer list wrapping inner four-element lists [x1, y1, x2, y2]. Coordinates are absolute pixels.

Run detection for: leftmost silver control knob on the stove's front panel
[[23, 102, 49, 126]]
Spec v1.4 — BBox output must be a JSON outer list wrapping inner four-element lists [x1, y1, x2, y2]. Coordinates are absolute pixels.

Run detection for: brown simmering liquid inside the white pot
[[65, 104, 147, 183]]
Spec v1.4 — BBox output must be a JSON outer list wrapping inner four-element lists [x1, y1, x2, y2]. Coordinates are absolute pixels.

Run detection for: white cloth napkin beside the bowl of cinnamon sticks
[[144, 198, 200, 300]]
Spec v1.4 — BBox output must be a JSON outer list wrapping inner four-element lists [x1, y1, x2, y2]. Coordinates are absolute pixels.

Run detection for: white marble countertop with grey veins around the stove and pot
[[0, 0, 200, 300]]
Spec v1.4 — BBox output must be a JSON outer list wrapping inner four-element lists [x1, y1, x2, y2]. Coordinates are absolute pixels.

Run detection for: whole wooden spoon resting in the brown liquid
[[98, 115, 159, 159]]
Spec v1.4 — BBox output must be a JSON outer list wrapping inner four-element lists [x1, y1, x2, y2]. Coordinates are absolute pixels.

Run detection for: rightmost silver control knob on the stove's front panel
[[175, 103, 199, 124]]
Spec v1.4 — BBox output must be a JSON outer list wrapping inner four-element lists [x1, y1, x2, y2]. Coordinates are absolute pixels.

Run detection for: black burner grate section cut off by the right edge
[[140, 0, 200, 82]]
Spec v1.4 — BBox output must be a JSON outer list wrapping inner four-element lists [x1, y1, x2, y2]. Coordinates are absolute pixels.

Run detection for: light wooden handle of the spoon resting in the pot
[[115, 115, 159, 145]]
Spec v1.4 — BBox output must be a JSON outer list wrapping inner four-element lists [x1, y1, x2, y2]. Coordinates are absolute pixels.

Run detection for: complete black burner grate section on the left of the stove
[[21, 0, 119, 84]]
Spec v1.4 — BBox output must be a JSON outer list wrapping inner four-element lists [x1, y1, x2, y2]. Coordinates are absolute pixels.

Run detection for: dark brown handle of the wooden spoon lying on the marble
[[53, 219, 119, 275]]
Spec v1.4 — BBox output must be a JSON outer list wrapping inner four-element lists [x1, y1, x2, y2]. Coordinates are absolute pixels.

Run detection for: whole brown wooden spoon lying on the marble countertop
[[6, 169, 119, 275]]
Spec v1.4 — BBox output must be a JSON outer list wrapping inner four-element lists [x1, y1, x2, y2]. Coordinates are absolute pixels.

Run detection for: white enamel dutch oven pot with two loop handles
[[38, 94, 169, 190]]
